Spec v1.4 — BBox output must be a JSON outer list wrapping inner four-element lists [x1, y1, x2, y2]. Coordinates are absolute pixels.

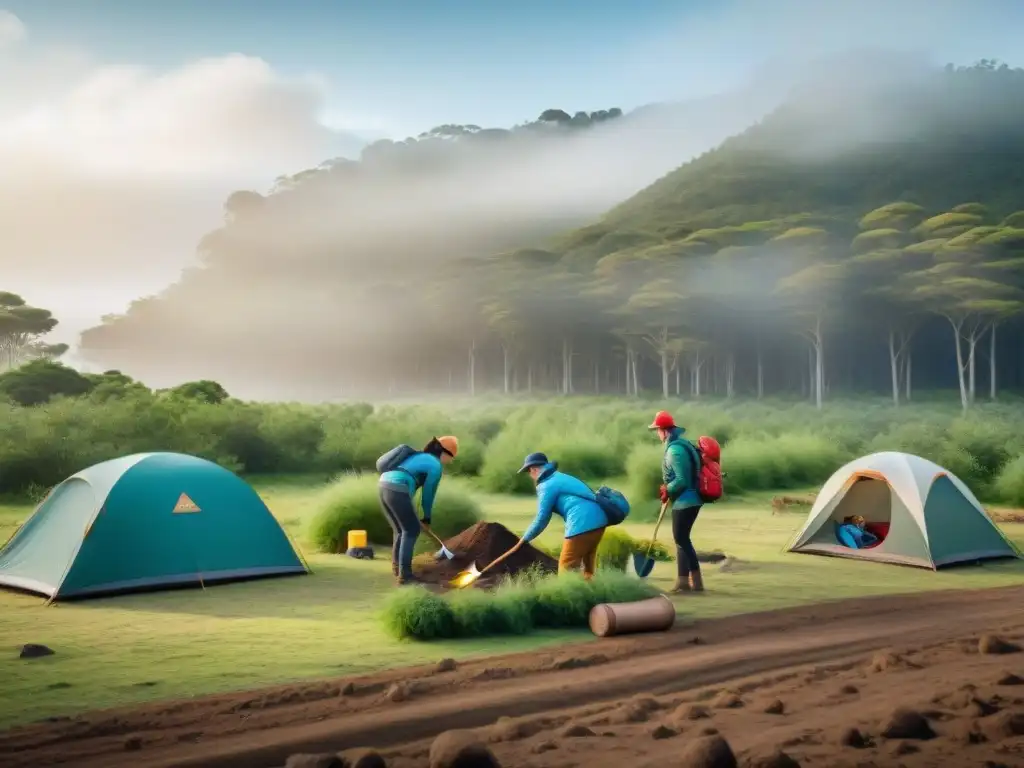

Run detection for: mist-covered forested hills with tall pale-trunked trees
[[75, 61, 1024, 409]]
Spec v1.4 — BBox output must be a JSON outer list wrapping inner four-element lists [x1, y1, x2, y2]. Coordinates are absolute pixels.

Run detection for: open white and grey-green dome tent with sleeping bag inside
[[786, 452, 1020, 568]]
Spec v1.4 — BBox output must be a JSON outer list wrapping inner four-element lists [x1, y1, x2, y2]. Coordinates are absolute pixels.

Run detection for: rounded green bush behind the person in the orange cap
[[309, 474, 480, 552]]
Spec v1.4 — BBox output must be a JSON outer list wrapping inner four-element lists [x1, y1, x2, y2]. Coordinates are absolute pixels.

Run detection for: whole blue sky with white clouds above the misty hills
[[0, 0, 1024, 358]]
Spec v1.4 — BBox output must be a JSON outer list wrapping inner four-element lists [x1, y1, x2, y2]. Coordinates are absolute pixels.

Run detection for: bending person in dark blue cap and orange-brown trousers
[[505, 453, 608, 579]]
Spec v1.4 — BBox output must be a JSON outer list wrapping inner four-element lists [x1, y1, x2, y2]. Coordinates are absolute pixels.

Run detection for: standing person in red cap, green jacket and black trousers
[[648, 411, 703, 593]]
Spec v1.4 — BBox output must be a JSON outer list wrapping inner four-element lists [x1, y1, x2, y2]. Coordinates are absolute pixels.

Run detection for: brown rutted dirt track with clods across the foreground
[[0, 587, 1024, 768]]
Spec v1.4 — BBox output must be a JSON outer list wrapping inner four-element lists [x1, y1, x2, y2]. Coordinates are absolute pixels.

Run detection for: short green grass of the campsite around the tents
[[0, 476, 1024, 727]]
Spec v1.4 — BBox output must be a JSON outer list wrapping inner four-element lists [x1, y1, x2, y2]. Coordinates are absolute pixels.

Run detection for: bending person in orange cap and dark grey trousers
[[378, 435, 459, 585]]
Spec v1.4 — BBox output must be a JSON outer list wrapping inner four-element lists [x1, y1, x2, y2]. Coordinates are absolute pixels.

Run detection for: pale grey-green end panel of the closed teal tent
[[0, 477, 99, 597]]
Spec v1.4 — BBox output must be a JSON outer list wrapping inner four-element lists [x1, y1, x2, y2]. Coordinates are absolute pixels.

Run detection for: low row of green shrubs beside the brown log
[[381, 570, 659, 640]]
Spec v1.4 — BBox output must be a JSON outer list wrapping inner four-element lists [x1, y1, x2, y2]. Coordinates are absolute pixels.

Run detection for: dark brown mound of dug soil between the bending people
[[413, 522, 558, 588]]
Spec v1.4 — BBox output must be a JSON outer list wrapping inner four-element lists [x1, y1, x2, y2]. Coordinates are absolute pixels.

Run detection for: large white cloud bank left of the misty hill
[[0, 11, 374, 341]]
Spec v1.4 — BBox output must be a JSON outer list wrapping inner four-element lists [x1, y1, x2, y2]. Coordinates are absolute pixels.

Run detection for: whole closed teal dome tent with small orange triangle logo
[[0, 453, 307, 600]]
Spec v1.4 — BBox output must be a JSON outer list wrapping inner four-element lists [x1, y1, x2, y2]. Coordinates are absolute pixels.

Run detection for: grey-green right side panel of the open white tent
[[925, 475, 1017, 566]]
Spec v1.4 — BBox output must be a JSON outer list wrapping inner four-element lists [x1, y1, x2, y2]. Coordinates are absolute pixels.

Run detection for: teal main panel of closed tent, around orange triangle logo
[[59, 454, 306, 597]]
